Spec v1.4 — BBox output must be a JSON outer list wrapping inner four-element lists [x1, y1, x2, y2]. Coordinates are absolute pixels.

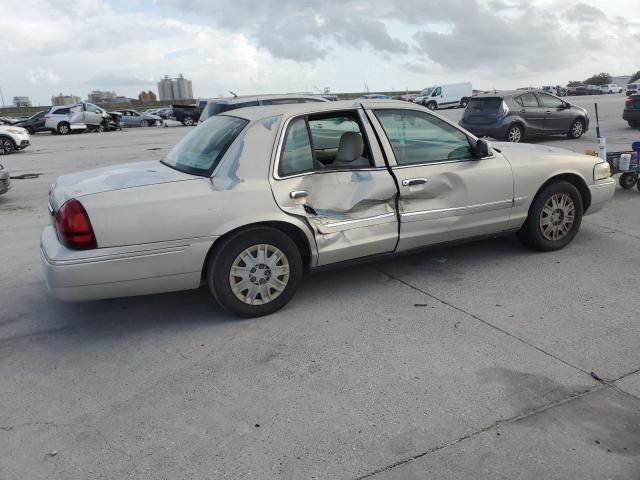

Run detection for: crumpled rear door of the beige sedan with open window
[[271, 110, 398, 265]]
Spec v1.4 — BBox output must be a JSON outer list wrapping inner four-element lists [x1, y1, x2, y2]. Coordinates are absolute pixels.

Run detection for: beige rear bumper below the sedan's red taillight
[[40, 226, 213, 301]]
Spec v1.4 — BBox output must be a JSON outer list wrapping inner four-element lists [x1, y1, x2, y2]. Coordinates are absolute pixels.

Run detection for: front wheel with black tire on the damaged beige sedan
[[518, 181, 584, 252]]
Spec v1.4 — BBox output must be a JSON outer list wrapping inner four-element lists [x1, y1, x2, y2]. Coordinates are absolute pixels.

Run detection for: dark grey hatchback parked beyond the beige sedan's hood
[[460, 90, 589, 143]]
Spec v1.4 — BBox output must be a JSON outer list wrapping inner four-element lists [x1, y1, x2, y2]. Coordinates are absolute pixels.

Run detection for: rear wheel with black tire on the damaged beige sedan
[[207, 227, 303, 317]]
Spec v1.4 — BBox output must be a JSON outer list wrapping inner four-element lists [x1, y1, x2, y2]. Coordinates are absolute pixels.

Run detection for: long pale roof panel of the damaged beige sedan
[[220, 99, 416, 121]]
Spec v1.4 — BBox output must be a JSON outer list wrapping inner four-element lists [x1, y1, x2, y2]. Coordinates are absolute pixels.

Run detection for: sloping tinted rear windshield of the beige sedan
[[162, 115, 249, 177]]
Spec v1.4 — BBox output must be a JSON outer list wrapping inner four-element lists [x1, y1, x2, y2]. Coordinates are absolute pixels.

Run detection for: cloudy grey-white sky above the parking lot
[[0, 0, 640, 104]]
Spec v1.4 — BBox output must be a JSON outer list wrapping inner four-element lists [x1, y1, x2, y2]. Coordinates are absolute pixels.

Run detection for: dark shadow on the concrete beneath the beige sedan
[[0, 233, 532, 348]]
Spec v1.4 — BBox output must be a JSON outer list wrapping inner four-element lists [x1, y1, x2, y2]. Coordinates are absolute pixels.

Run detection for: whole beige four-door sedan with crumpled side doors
[[41, 100, 615, 317]]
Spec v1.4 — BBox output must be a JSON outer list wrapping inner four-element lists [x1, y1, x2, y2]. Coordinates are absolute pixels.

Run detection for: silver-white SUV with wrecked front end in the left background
[[44, 102, 107, 135]]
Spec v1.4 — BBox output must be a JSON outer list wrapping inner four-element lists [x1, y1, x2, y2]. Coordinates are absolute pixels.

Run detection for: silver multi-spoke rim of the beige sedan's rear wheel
[[229, 244, 289, 305]]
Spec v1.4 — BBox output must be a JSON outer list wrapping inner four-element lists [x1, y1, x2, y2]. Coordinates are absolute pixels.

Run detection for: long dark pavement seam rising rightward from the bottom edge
[[354, 384, 610, 480]]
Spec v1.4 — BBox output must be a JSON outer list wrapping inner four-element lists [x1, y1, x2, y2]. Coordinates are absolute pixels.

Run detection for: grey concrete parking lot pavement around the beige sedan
[[0, 96, 640, 480]]
